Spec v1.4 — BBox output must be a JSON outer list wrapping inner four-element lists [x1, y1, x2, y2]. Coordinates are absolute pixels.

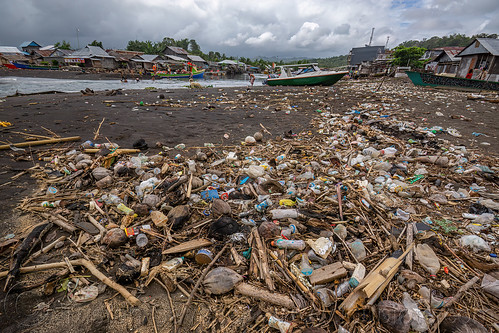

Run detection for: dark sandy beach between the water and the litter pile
[[0, 73, 499, 332]]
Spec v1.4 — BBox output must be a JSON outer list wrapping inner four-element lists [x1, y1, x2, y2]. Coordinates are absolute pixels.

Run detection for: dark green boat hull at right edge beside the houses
[[405, 71, 499, 91]]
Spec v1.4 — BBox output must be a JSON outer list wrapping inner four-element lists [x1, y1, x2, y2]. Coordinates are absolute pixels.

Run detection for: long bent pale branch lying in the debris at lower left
[[0, 259, 141, 306]]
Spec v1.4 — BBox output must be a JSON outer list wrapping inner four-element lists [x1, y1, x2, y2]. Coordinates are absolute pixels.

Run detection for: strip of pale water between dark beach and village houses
[[0, 75, 263, 98]]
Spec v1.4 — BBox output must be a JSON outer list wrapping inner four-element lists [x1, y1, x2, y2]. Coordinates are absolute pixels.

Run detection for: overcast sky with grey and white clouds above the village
[[0, 0, 499, 58]]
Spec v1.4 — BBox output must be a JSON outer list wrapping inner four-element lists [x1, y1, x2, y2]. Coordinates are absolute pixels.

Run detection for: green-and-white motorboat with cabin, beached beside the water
[[266, 63, 348, 86]]
